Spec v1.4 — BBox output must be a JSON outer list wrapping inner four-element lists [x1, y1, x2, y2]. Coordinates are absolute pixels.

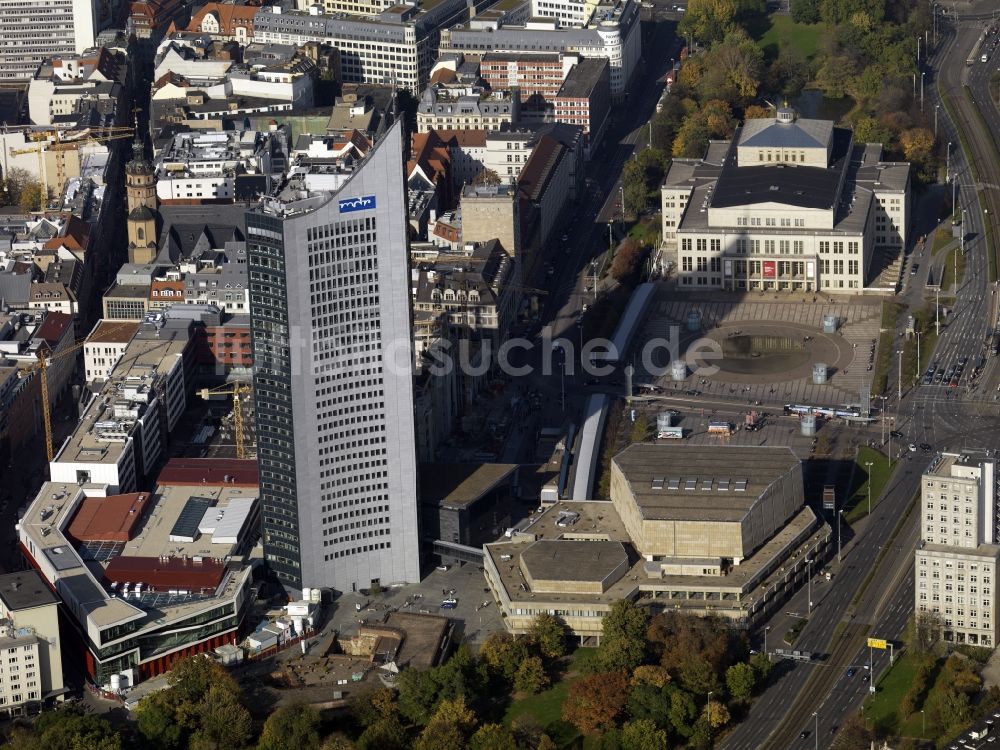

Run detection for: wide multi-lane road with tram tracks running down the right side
[[723, 5, 1000, 750]]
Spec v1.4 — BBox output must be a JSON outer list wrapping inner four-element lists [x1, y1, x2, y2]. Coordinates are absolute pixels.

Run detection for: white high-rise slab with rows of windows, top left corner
[[0, 0, 115, 81]]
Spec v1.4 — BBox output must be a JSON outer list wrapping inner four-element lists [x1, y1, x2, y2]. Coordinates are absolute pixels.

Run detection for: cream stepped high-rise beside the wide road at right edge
[[914, 453, 1000, 648]]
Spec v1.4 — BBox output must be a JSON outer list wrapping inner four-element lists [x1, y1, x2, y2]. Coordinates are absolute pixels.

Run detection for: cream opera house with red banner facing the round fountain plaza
[[661, 109, 910, 294]]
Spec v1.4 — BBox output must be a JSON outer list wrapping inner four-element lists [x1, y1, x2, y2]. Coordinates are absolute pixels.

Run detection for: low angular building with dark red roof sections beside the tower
[[21, 459, 260, 693]]
